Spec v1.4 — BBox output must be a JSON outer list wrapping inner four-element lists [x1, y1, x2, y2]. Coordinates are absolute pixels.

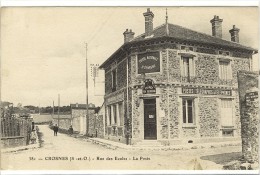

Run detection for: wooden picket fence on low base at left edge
[[0, 110, 32, 147]]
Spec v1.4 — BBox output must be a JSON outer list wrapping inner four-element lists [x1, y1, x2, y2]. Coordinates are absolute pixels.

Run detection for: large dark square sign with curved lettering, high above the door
[[137, 52, 160, 74]]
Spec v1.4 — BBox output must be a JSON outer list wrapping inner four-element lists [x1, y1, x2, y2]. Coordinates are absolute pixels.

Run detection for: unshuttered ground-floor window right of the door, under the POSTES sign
[[182, 98, 194, 124]]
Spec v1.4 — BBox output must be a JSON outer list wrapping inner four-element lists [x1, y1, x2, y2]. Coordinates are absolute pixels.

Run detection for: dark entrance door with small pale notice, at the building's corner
[[144, 98, 157, 140]]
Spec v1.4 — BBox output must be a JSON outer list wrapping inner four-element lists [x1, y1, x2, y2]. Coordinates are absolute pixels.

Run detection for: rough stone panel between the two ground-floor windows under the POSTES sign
[[198, 97, 220, 137]]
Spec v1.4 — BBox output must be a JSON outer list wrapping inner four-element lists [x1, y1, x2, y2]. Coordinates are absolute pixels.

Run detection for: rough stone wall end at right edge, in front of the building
[[238, 71, 259, 162]]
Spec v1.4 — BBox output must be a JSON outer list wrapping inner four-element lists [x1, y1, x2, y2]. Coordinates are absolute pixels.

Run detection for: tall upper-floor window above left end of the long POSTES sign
[[181, 57, 195, 82]]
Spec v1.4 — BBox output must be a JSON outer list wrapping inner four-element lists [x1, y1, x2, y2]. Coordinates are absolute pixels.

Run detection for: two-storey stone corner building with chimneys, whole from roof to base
[[100, 9, 257, 145]]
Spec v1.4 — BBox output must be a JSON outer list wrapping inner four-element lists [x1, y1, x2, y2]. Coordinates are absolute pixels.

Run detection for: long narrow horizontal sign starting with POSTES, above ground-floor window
[[182, 88, 232, 96]]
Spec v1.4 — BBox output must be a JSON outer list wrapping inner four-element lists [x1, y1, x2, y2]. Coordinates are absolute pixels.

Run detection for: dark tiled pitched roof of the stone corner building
[[132, 23, 257, 51]]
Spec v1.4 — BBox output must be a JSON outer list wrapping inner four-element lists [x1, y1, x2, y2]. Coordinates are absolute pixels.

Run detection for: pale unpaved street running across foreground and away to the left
[[1, 125, 241, 170]]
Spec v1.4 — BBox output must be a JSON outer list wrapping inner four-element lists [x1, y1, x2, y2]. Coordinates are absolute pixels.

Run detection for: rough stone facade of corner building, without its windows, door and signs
[[101, 44, 252, 144]]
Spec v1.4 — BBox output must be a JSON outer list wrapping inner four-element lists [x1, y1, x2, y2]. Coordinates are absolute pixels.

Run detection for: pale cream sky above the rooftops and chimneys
[[1, 7, 259, 106]]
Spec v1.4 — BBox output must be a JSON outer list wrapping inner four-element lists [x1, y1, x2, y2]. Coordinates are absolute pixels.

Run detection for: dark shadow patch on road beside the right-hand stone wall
[[200, 152, 242, 165]]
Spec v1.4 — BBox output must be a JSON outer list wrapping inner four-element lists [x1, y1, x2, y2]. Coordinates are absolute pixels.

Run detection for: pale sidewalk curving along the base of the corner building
[[88, 138, 241, 151]]
